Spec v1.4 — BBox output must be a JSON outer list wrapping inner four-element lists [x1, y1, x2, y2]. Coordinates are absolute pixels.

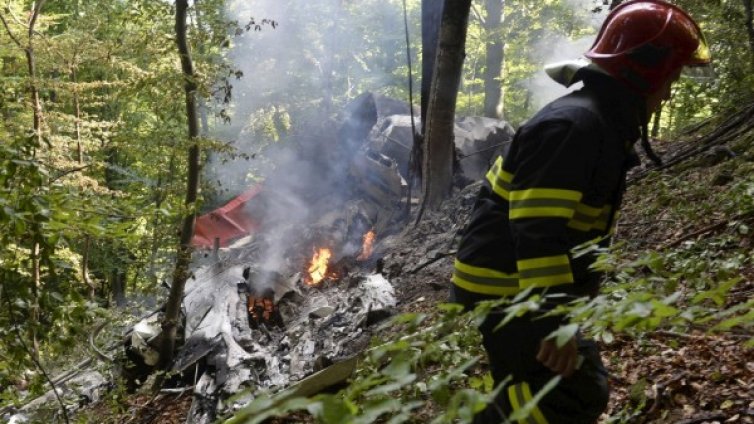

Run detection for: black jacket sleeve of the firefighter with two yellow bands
[[504, 117, 600, 289]]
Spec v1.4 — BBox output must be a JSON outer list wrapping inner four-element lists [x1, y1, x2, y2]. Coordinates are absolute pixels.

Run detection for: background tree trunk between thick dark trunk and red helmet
[[484, 0, 505, 119]]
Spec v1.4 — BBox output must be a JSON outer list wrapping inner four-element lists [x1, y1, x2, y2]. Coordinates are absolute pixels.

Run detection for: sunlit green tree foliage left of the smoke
[[0, 0, 238, 404]]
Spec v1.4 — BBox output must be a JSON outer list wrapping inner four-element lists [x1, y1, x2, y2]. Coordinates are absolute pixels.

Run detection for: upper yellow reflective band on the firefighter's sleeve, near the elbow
[[509, 188, 582, 219]]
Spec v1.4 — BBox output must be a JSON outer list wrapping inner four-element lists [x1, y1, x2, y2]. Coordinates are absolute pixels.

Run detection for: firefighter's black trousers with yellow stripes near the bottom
[[474, 313, 609, 424]]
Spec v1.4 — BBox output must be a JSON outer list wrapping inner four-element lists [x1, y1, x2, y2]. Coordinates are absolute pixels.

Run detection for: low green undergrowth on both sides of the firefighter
[[227, 129, 754, 424]]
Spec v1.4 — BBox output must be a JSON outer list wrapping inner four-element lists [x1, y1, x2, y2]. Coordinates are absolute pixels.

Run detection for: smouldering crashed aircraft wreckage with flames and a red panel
[[25, 93, 513, 423]]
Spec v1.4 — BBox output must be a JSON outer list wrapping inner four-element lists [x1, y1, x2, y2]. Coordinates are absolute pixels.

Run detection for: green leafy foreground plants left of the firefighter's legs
[[226, 304, 506, 423]]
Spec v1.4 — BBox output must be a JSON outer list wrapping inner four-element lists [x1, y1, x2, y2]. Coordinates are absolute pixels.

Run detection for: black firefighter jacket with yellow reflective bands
[[452, 76, 642, 306]]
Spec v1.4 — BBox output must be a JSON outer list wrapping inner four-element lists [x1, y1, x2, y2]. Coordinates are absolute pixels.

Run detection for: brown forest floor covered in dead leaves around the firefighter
[[78, 110, 754, 424]]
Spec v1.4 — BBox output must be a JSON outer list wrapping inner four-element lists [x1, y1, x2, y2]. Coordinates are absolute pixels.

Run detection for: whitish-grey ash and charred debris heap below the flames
[[173, 243, 396, 423]]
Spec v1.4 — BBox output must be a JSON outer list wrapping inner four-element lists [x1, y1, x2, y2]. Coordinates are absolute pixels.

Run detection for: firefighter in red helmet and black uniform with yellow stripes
[[451, 0, 710, 423]]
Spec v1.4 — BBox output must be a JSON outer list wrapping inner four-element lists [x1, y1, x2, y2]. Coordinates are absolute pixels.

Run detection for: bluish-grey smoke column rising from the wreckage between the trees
[[197, 0, 418, 289]]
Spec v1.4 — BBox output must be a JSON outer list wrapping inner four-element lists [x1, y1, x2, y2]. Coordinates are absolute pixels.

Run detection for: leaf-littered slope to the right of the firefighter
[[604, 108, 754, 423]]
